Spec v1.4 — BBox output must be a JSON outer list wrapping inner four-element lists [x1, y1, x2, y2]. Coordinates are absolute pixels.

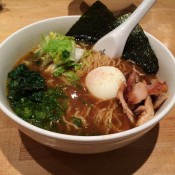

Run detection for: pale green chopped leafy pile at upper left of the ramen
[[34, 32, 80, 80]]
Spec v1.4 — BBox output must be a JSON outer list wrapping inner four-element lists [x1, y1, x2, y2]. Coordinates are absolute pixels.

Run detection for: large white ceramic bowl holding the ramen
[[0, 16, 175, 153]]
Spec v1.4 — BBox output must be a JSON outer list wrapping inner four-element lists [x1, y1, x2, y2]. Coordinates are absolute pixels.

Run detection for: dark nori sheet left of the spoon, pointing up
[[66, 1, 116, 45]]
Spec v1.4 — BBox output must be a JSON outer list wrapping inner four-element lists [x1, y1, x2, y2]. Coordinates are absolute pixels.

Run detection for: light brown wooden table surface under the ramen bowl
[[0, 0, 175, 175]]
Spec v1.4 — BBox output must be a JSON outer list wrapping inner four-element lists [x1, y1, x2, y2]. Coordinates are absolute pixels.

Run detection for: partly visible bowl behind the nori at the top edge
[[84, 0, 132, 12]]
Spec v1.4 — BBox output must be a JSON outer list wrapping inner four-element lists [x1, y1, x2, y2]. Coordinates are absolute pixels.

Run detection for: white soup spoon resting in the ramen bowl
[[93, 0, 156, 58]]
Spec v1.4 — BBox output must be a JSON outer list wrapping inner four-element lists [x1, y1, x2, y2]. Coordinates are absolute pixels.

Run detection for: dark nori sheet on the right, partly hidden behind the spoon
[[115, 14, 159, 74]]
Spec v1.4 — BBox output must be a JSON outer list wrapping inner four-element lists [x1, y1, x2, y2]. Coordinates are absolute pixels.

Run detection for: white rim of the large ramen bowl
[[0, 15, 175, 143]]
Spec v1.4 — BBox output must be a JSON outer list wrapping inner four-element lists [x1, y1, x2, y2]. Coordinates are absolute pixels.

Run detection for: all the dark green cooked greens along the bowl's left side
[[7, 64, 67, 131]]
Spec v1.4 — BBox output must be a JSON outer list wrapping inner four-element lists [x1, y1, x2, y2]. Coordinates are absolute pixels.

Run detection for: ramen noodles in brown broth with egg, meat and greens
[[7, 32, 168, 136]]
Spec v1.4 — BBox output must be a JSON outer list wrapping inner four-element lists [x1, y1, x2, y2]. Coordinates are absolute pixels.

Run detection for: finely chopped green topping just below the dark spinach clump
[[11, 89, 67, 130]]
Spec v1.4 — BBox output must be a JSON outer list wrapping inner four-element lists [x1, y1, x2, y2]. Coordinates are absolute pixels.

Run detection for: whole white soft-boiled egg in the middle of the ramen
[[85, 66, 126, 100]]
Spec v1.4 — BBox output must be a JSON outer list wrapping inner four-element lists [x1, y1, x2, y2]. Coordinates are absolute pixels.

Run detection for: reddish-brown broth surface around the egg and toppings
[[13, 50, 157, 135]]
